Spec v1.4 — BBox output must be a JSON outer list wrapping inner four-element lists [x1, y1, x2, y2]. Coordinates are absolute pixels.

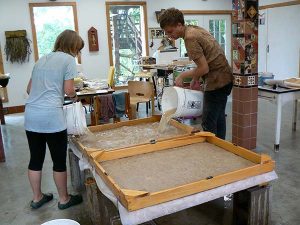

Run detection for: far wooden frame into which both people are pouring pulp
[[71, 115, 194, 160]]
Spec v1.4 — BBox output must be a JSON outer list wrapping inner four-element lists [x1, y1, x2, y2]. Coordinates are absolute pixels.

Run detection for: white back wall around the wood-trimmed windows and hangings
[[0, 0, 231, 107]]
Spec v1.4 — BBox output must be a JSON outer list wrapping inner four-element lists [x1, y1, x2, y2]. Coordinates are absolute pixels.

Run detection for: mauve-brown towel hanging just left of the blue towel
[[97, 94, 116, 122]]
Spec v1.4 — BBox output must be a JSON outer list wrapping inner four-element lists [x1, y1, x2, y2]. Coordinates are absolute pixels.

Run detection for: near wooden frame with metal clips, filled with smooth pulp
[[93, 132, 275, 211]]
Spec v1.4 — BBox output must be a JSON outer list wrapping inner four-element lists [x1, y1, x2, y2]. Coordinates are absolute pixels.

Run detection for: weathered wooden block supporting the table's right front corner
[[233, 185, 271, 225]]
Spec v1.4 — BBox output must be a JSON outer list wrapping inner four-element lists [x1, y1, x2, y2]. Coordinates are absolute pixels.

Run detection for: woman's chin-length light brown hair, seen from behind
[[53, 30, 84, 57]]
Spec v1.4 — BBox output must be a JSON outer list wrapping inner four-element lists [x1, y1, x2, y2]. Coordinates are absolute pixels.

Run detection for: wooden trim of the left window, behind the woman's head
[[29, 2, 81, 63]]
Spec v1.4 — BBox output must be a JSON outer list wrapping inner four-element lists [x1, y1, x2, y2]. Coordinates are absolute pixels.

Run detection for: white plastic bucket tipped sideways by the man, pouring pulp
[[161, 87, 203, 117]]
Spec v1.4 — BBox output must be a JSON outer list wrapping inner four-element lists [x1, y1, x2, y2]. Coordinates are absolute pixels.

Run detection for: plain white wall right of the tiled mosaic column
[[259, 5, 300, 79]]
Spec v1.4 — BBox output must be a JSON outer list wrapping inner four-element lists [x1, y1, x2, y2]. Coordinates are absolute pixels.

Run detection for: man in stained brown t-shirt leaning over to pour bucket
[[159, 8, 233, 139]]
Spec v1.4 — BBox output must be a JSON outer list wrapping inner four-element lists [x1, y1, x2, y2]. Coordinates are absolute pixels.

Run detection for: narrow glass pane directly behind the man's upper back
[[209, 20, 226, 53]]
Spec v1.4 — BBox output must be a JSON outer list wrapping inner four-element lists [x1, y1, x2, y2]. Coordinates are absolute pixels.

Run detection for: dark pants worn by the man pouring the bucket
[[202, 83, 232, 139]]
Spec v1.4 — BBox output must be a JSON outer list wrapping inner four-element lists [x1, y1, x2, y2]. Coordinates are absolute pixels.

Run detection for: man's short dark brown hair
[[159, 8, 184, 29]]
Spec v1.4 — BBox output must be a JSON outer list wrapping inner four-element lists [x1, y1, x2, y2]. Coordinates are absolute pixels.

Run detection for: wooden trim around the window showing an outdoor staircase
[[105, 1, 149, 66]]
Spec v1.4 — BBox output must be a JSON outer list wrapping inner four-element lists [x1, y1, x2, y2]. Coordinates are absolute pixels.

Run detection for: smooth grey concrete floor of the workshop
[[0, 100, 300, 225]]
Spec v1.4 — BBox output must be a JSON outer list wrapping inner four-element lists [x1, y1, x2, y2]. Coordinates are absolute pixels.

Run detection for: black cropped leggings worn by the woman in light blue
[[26, 130, 68, 172]]
